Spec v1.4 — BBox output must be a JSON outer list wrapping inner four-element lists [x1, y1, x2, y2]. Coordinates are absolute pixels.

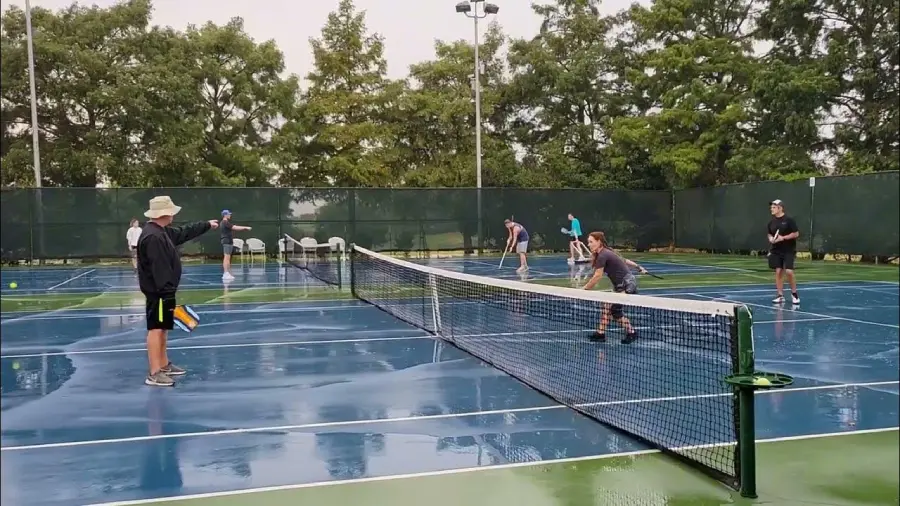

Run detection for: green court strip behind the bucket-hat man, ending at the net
[[0, 287, 350, 312]]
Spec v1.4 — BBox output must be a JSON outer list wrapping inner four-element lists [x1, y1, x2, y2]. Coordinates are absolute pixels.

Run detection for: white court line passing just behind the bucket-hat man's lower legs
[[0, 315, 835, 359]]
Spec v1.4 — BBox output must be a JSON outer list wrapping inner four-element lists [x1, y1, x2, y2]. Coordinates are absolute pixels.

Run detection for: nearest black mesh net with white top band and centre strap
[[350, 246, 753, 488]]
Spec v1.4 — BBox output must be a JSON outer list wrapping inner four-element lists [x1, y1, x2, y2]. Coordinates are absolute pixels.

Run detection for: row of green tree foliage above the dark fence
[[0, 0, 900, 189]]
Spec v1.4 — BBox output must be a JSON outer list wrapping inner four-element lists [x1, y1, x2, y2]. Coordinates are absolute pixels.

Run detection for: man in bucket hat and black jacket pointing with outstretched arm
[[137, 196, 219, 387]]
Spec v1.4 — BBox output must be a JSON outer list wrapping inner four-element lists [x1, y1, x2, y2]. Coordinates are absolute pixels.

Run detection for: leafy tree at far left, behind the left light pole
[[2, 0, 150, 186]]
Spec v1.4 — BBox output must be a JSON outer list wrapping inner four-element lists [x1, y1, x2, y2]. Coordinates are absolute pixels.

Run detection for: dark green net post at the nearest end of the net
[[737, 306, 756, 498]]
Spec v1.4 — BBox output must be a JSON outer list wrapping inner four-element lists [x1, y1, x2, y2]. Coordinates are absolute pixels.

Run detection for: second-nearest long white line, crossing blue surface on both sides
[[0, 380, 900, 452]]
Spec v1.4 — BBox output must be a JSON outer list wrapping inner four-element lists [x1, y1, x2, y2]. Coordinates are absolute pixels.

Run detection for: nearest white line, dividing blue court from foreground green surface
[[81, 427, 900, 506]]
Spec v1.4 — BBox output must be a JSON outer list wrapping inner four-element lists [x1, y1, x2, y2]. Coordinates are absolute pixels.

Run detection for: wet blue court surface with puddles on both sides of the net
[[0, 257, 900, 506]]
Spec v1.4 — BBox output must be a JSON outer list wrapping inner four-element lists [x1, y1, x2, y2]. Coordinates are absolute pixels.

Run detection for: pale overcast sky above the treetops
[[0, 0, 631, 78]]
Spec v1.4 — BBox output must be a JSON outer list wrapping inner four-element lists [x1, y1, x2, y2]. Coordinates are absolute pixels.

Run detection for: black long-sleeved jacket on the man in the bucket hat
[[137, 221, 210, 297]]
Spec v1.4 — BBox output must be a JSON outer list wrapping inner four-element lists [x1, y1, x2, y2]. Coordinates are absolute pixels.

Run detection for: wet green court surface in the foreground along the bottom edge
[[112, 429, 900, 506]]
